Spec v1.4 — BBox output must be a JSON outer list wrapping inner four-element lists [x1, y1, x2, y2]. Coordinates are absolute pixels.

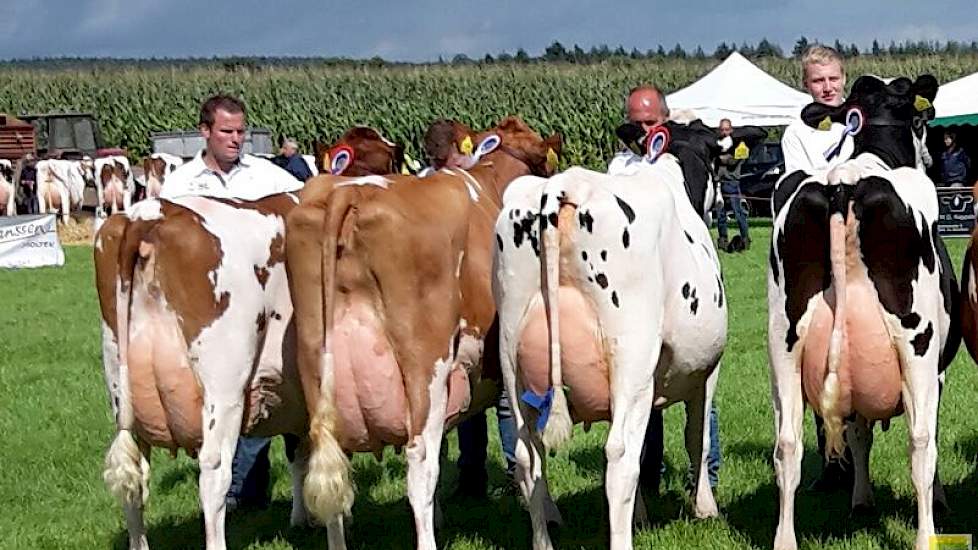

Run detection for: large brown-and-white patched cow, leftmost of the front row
[[95, 127, 404, 548]]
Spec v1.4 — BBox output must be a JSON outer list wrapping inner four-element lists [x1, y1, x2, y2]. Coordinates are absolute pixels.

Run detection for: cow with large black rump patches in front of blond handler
[[768, 75, 960, 550]]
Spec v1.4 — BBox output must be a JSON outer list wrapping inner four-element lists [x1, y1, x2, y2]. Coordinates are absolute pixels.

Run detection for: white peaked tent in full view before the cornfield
[[666, 52, 812, 126]]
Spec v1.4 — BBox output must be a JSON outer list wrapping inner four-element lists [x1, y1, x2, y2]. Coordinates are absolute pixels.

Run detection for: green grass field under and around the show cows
[[0, 226, 978, 550]]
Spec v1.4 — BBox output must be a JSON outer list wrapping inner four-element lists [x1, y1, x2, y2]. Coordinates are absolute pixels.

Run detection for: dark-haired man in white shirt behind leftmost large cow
[[160, 95, 303, 200]]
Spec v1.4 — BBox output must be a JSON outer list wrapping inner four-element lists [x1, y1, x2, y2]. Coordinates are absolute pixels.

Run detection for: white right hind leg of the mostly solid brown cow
[[404, 353, 455, 550]]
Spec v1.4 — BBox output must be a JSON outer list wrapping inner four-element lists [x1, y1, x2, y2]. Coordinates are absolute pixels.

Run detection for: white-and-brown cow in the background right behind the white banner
[[35, 159, 96, 223]]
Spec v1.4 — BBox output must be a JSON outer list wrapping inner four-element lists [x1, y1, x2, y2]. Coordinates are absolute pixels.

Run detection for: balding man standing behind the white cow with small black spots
[[608, 84, 721, 494]]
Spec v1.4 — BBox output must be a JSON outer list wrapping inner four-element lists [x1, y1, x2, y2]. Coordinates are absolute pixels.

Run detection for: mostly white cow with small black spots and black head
[[493, 121, 727, 550]]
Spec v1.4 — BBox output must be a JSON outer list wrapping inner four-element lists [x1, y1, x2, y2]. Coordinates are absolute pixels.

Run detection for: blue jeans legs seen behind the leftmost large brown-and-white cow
[[227, 434, 299, 508]]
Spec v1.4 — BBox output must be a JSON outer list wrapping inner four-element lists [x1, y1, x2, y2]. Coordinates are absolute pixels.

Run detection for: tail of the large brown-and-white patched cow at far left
[[102, 222, 155, 506]]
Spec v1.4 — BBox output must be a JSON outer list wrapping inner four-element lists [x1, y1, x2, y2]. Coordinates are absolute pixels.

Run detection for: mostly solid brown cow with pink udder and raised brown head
[[286, 117, 561, 549]]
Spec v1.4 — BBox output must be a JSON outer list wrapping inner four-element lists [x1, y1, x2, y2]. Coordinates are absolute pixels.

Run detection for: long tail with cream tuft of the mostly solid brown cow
[[303, 189, 356, 523]]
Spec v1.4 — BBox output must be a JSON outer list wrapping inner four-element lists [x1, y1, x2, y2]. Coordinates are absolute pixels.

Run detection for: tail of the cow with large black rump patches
[[820, 196, 848, 464]]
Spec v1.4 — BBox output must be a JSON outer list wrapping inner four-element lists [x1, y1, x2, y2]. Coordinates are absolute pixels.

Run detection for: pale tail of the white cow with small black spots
[[540, 193, 574, 449]]
